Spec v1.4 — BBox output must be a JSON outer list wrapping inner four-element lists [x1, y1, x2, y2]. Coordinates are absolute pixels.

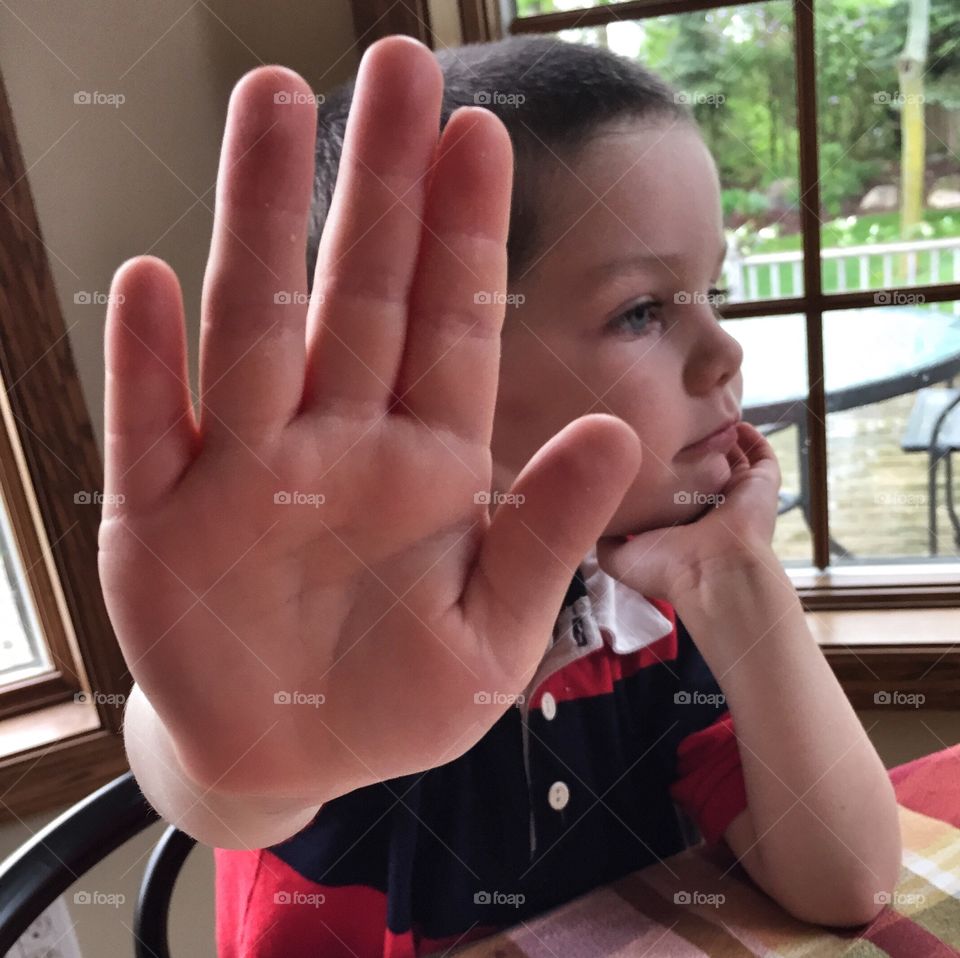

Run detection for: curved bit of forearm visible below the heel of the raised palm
[[123, 685, 320, 849]]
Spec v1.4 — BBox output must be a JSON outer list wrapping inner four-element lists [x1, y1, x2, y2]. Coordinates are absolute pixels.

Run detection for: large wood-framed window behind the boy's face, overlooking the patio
[[430, 0, 960, 610]]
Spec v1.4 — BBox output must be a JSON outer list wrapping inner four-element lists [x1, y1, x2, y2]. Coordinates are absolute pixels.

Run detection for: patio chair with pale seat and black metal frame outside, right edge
[[900, 386, 960, 555]]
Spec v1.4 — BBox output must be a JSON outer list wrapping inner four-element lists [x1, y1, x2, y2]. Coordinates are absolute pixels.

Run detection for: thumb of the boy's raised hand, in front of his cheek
[[463, 413, 642, 681]]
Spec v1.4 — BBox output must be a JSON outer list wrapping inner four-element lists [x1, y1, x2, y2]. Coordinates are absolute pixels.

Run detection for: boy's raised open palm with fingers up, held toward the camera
[[99, 36, 641, 802]]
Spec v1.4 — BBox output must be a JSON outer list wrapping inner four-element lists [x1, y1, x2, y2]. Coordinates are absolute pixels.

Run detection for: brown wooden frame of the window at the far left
[[0, 62, 132, 820]]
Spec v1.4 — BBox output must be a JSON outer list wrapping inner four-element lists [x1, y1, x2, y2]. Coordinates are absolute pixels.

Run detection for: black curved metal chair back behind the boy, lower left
[[0, 772, 196, 958]]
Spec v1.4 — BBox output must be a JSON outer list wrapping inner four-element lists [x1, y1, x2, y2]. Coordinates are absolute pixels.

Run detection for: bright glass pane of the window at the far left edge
[[0, 499, 50, 686]]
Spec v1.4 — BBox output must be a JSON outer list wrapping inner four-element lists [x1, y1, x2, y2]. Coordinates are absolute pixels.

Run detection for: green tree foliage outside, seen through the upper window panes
[[517, 0, 960, 251]]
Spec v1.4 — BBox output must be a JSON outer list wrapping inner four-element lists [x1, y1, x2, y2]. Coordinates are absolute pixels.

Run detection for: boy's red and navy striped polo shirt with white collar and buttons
[[214, 549, 747, 958]]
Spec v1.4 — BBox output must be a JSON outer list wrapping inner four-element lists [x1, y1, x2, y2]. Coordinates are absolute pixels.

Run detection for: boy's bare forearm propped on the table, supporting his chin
[[674, 550, 901, 924]]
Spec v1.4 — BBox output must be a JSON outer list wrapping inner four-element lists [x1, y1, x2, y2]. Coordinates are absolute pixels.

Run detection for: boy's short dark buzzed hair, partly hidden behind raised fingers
[[307, 34, 695, 288]]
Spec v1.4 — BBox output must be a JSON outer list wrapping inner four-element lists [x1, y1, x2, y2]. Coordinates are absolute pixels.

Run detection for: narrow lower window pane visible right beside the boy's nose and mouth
[[722, 314, 813, 566]]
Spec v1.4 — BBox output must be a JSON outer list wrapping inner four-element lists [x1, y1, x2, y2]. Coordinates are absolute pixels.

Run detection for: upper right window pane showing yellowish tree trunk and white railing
[[816, 0, 960, 292]]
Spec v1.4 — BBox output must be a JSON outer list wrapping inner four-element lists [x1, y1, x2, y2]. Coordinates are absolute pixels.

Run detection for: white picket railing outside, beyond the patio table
[[724, 236, 960, 315]]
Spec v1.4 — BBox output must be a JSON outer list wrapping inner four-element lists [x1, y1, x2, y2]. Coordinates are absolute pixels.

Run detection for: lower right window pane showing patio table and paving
[[824, 303, 960, 563]]
